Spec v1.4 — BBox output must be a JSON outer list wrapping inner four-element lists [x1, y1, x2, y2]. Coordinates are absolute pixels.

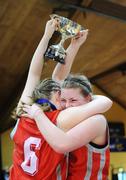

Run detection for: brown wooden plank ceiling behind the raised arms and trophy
[[0, 0, 126, 132]]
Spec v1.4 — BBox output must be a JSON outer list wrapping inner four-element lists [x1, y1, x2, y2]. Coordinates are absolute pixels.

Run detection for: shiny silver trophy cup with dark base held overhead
[[45, 14, 84, 64]]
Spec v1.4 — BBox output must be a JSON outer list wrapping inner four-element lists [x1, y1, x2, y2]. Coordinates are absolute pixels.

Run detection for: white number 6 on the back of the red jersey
[[21, 137, 41, 176]]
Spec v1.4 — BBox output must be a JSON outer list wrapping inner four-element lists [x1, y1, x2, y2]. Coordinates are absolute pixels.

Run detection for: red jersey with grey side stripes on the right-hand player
[[67, 131, 110, 180]]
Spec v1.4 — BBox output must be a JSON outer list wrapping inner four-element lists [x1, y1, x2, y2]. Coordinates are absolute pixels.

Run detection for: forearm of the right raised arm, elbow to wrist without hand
[[52, 44, 79, 82]]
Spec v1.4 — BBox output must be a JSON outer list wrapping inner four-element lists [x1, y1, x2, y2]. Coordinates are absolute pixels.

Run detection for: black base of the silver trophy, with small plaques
[[44, 46, 66, 64]]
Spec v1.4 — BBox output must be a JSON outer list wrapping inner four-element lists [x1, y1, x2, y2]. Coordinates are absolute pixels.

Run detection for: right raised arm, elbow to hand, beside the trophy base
[[52, 30, 88, 83]]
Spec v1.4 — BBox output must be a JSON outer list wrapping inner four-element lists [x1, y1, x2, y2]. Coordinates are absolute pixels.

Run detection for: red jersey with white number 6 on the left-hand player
[[10, 110, 67, 180]]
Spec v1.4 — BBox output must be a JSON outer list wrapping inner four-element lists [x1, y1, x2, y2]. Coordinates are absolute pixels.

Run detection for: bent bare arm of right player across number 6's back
[[24, 104, 106, 153]]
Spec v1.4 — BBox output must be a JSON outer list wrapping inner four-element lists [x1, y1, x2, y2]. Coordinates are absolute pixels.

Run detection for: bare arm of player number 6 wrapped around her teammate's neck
[[57, 96, 112, 131]]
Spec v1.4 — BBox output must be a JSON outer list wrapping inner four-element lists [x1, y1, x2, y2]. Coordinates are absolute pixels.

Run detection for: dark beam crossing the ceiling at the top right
[[52, 0, 126, 20]]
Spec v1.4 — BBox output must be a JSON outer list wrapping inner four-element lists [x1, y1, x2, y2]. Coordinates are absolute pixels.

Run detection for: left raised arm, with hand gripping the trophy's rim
[[17, 20, 58, 114]]
